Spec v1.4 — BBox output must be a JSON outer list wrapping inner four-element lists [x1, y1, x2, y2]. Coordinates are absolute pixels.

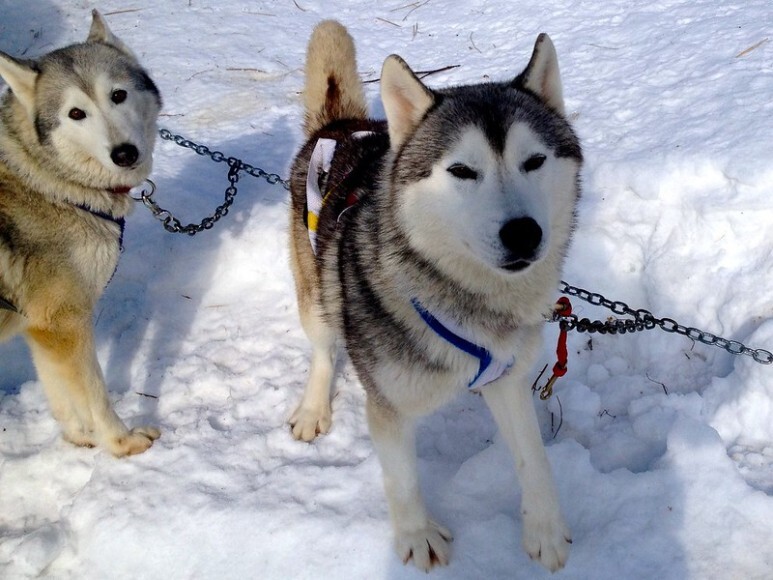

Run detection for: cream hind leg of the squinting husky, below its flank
[[290, 300, 337, 441]]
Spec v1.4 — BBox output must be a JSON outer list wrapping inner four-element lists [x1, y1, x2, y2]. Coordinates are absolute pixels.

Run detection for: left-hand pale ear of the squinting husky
[[381, 54, 435, 149]]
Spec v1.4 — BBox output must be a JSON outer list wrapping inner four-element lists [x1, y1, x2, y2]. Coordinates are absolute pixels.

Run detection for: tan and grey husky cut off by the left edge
[[0, 10, 161, 456]]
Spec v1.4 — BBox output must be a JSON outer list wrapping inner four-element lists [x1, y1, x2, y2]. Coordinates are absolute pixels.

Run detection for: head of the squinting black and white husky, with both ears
[[381, 34, 582, 278]]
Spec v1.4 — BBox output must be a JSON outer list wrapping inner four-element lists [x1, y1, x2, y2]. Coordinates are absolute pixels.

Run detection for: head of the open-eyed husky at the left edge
[[0, 10, 161, 189]]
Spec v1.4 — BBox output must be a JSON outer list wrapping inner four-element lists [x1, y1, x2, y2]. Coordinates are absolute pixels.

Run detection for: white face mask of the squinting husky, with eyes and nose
[[395, 118, 577, 275]]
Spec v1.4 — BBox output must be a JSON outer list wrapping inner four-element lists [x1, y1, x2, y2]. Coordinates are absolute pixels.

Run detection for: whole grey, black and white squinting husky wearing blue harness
[[290, 21, 582, 570]]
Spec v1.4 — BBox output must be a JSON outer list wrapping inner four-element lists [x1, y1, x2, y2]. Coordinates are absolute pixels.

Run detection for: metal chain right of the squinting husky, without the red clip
[[555, 280, 773, 365]]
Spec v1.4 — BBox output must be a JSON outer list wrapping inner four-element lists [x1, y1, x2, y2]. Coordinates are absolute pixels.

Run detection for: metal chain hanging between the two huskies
[[135, 129, 290, 236]]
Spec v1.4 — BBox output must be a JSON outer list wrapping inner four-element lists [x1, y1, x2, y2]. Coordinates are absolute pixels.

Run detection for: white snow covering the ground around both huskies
[[0, 0, 773, 580]]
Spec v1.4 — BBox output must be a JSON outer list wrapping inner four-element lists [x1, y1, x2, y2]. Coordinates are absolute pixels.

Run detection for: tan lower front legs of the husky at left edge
[[27, 316, 161, 457]]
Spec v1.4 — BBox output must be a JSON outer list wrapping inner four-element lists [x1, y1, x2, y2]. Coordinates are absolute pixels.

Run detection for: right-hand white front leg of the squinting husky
[[481, 373, 572, 572]]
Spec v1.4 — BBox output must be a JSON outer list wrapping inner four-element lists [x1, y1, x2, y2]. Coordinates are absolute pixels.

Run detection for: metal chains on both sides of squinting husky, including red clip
[[139, 129, 773, 400]]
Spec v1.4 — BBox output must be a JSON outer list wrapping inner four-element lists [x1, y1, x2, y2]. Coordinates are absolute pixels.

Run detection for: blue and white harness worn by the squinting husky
[[306, 131, 515, 391]]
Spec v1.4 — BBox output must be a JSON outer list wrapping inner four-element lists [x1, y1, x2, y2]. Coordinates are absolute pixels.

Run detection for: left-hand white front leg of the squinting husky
[[367, 395, 453, 572]]
